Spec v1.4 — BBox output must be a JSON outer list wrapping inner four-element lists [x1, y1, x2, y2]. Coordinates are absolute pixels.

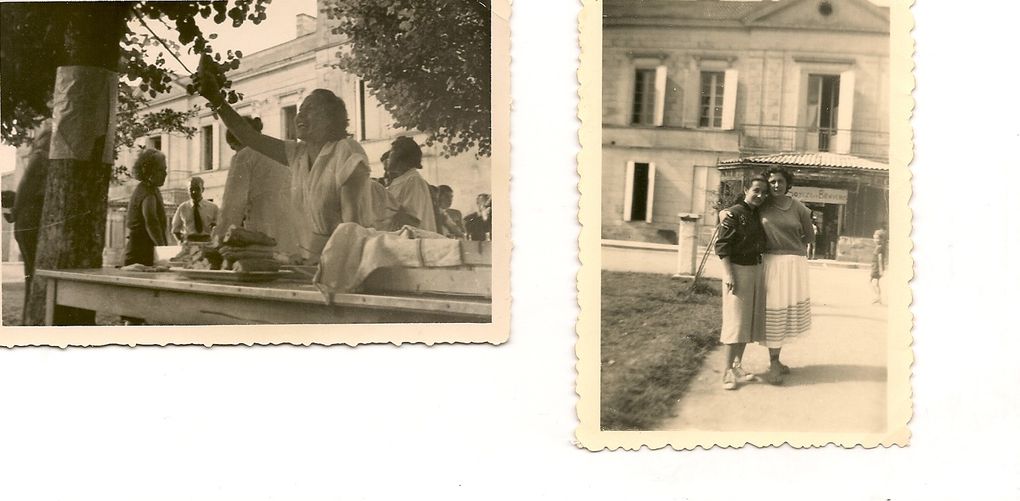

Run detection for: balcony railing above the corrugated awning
[[737, 124, 889, 161]]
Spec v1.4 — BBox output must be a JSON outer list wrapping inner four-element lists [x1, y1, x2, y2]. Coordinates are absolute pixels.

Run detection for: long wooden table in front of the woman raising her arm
[[36, 268, 492, 325]]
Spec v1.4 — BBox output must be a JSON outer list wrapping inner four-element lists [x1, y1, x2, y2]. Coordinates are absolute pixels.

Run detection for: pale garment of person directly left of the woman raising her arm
[[216, 144, 301, 255]]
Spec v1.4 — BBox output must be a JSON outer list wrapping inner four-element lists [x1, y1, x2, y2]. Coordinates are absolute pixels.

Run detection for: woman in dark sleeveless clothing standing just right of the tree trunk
[[124, 149, 166, 266]]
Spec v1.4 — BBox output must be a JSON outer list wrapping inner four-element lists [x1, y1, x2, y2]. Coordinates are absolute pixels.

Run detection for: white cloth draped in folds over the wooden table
[[313, 223, 464, 301]]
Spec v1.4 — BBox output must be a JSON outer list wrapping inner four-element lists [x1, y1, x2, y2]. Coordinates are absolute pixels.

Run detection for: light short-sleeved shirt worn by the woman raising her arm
[[284, 138, 397, 260]]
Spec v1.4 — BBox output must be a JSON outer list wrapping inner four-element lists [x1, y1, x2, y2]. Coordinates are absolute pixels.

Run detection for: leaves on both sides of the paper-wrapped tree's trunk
[[0, 0, 270, 145]]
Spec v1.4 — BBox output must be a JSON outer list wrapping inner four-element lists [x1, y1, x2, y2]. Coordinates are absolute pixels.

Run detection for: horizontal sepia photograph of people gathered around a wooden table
[[0, 0, 510, 346]]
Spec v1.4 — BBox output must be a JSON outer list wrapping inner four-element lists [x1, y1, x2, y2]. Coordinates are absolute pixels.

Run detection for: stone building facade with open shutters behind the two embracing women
[[602, 0, 889, 259]]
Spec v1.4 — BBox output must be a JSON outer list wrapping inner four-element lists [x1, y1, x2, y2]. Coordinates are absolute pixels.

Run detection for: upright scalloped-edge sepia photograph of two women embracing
[[577, 0, 913, 449]]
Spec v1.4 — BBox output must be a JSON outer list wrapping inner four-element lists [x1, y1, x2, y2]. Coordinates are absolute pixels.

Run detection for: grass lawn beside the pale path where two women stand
[[602, 271, 721, 430]]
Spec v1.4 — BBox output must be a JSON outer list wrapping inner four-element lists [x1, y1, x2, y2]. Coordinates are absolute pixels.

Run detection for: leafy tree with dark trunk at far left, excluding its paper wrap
[[0, 0, 269, 324]]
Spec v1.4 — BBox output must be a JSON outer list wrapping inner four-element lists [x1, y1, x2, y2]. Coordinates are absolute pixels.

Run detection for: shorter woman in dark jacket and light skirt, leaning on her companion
[[715, 177, 769, 390]]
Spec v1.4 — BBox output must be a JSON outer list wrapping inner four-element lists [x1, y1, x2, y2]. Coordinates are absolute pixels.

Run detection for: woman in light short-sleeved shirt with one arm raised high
[[198, 56, 396, 262]]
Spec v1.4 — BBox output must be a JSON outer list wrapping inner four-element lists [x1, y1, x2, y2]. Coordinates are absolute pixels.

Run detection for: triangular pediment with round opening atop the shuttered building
[[744, 0, 889, 33]]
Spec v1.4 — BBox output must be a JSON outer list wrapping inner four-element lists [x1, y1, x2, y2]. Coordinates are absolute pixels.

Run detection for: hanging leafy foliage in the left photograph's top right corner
[[325, 0, 492, 155]]
